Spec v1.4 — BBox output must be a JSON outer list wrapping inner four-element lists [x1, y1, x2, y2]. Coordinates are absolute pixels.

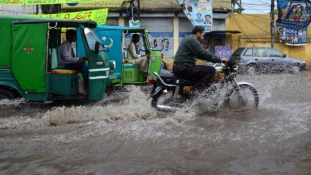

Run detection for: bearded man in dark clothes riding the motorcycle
[[173, 26, 227, 93]]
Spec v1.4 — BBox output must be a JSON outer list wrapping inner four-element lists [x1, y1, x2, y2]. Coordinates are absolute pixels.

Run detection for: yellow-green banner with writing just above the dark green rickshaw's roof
[[27, 9, 108, 24]]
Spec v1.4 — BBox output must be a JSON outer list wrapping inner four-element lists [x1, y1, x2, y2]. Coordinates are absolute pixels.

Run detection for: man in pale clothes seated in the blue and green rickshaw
[[127, 34, 148, 75]]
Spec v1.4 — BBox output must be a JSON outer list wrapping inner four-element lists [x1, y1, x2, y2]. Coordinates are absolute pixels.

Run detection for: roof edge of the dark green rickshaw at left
[[0, 15, 97, 28]]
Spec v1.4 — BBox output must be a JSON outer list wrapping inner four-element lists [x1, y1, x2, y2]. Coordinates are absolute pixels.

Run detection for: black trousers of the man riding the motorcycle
[[173, 63, 216, 90]]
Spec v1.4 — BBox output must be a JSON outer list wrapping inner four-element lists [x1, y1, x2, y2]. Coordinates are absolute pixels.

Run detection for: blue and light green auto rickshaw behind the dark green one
[[77, 25, 164, 86]]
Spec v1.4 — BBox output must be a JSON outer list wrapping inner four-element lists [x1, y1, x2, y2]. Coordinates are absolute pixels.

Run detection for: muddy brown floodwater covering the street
[[0, 72, 311, 175]]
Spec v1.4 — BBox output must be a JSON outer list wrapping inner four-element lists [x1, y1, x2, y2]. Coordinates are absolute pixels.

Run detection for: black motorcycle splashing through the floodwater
[[148, 59, 259, 111]]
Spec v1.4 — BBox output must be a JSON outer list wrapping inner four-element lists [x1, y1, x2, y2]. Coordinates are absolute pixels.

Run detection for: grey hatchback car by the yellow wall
[[231, 47, 306, 75]]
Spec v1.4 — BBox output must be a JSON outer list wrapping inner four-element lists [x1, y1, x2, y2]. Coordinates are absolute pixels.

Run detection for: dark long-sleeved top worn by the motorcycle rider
[[174, 35, 221, 64]]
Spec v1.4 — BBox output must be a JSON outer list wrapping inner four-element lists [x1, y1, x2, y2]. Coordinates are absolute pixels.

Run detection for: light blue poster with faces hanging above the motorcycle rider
[[177, 0, 213, 32]]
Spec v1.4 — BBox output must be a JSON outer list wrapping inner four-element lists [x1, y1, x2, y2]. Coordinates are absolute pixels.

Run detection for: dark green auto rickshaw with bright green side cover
[[0, 16, 113, 101]]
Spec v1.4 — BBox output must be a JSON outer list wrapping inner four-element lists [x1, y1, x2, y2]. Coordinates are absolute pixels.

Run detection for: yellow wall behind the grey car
[[226, 14, 311, 66]]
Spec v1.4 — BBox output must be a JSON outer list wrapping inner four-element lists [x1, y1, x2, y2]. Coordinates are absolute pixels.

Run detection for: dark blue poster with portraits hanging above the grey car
[[276, 0, 311, 46]]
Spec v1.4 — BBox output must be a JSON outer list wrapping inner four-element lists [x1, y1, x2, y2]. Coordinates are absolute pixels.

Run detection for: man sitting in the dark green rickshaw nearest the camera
[[57, 29, 89, 92]]
